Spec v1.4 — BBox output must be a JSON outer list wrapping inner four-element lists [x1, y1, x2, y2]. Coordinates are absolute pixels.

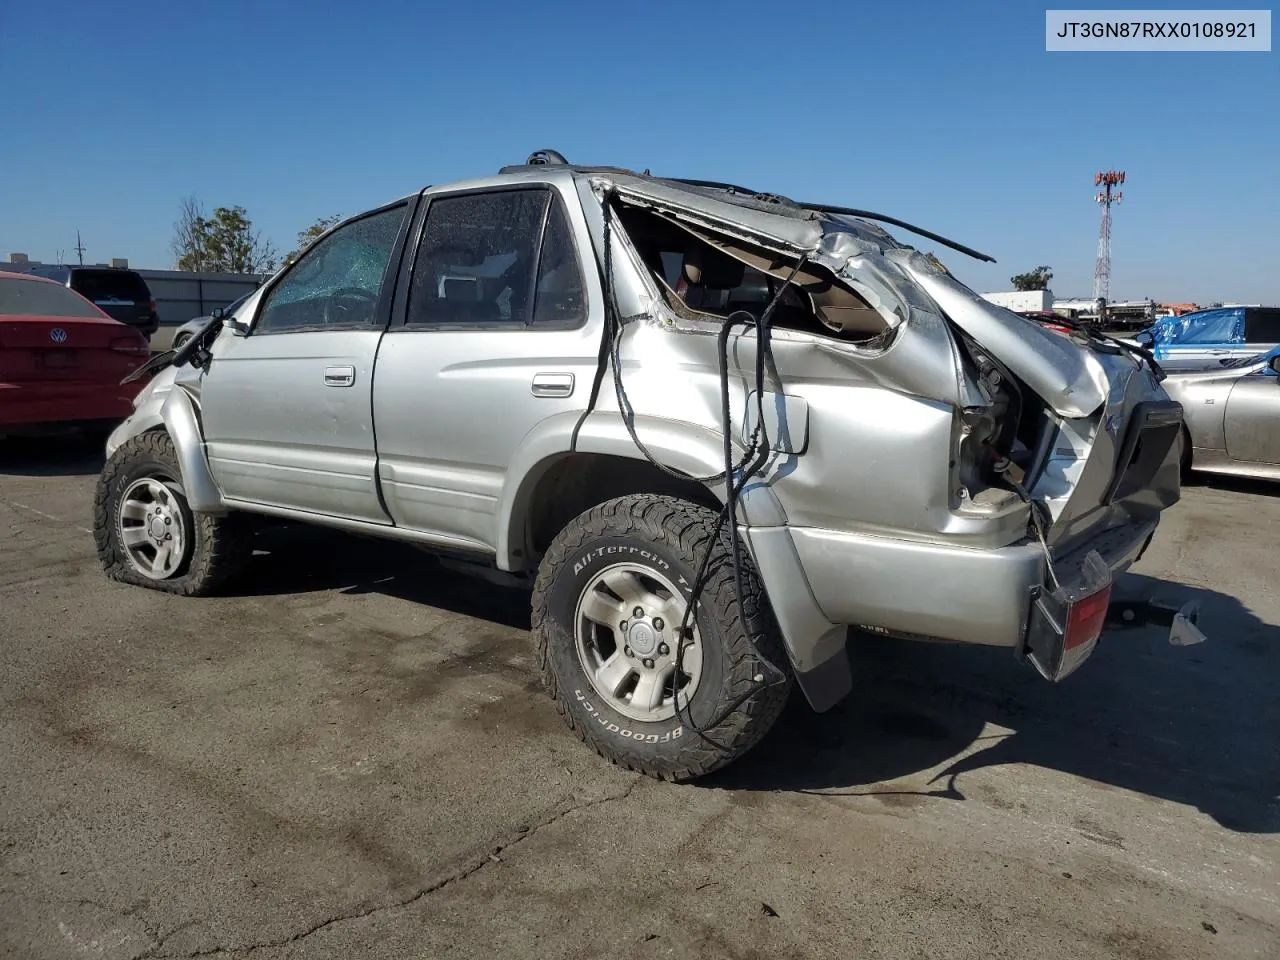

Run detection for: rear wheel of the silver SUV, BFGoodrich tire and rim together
[[532, 495, 791, 780]]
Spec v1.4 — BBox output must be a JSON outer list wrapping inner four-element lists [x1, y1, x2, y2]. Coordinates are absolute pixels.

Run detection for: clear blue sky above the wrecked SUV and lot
[[0, 0, 1280, 303]]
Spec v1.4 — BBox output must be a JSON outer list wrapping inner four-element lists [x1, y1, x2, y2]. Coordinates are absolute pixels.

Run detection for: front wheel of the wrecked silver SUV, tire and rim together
[[93, 431, 251, 596]]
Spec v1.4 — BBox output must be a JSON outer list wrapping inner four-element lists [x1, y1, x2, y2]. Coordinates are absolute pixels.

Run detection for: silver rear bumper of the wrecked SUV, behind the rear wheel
[[791, 521, 1156, 649]]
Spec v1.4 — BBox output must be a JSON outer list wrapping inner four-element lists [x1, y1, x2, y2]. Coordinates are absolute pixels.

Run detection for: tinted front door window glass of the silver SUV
[[253, 206, 407, 334]]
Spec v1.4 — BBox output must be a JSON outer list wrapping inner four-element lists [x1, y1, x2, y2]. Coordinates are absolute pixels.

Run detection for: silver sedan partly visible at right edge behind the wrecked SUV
[[1164, 347, 1280, 480]]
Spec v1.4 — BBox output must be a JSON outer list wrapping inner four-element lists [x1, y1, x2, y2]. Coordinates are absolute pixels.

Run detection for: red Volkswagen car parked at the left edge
[[0, 273, 151, 436]]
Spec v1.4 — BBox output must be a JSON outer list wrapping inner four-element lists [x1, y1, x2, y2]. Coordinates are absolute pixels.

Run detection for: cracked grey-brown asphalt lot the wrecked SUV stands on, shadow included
[[0, 442, 1280, 960]]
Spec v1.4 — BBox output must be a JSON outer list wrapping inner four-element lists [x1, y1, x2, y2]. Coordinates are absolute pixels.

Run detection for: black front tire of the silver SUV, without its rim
[[93, 430, 252, 596]]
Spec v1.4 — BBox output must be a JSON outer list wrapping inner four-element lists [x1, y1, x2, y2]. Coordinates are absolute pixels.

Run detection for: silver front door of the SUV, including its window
[[201, 204, 408, 524]]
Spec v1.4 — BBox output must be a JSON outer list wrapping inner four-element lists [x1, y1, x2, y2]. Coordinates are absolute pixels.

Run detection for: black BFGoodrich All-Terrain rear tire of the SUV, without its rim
[[532, 494, 792, 781]]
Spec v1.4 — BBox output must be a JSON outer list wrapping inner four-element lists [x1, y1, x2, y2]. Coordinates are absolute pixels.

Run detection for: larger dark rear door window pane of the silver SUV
[[408, 189, 550, 324]]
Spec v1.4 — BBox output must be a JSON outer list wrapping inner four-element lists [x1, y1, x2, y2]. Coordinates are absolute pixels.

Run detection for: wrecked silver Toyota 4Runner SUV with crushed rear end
[[95, 151, 1201, 778]]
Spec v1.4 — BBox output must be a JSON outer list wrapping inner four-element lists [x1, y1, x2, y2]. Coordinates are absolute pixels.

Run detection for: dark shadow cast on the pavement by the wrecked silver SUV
[[237, 525, 1280, 833]]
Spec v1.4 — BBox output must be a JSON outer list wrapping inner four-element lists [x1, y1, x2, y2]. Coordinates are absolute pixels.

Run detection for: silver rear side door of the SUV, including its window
[[374, 183, 603, 550]]
